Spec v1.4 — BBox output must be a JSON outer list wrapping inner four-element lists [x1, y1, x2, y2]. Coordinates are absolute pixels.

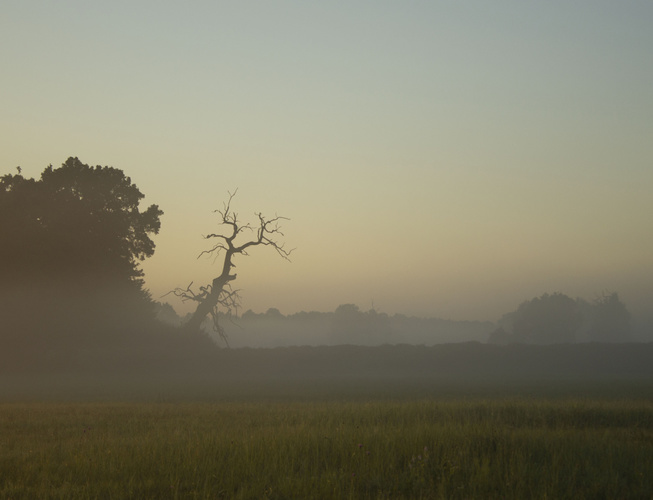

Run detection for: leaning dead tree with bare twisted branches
[[171, 191, 292, 345]]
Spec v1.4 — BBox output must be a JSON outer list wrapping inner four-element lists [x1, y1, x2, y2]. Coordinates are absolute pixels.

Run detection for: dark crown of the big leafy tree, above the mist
[[0, 158, 163, 284]]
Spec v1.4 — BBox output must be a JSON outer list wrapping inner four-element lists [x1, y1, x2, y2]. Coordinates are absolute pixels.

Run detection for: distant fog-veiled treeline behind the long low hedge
[[159, 293, 647, 347]]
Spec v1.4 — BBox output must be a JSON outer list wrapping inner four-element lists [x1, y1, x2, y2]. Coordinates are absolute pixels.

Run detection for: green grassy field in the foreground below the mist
[[0, 398, 653, 499]]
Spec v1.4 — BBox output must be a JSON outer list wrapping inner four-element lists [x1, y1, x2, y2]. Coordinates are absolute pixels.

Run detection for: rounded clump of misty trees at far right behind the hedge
[[489, 293, 632, 344]]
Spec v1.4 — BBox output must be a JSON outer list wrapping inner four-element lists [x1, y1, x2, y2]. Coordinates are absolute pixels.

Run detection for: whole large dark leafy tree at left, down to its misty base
[[0, 158, 215, 374]]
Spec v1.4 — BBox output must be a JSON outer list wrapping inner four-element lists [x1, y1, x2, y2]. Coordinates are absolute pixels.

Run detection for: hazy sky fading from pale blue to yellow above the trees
[[0, 0, 653, 320]]
